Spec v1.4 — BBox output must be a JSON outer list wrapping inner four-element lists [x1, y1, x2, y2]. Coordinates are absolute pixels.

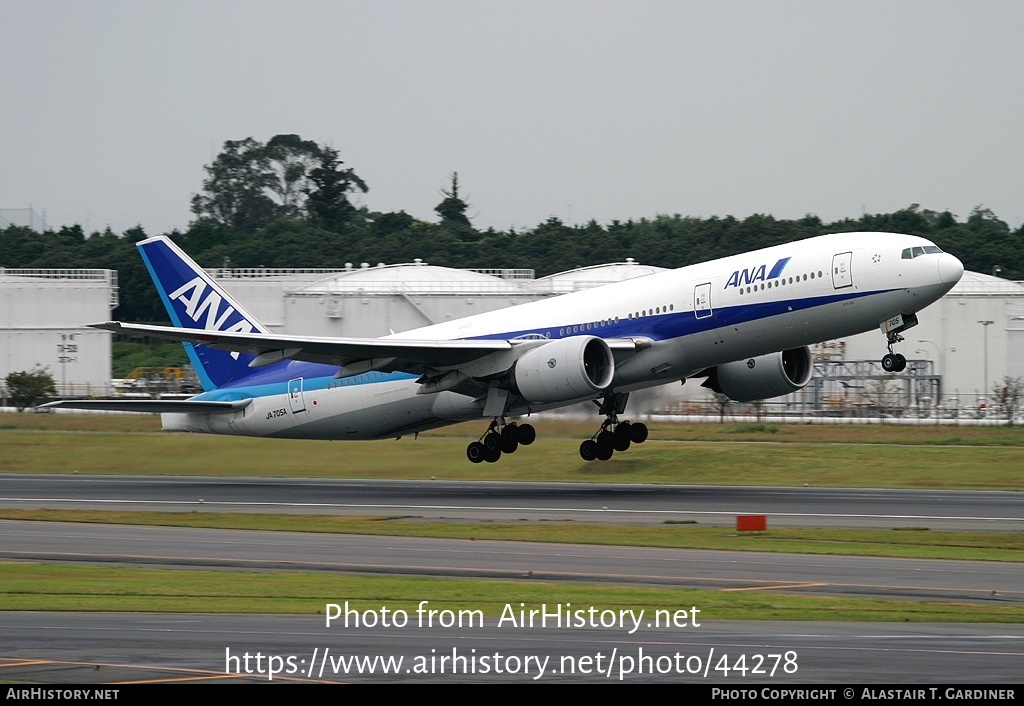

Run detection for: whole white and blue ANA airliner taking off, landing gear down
[[47, 233, 964, 462]]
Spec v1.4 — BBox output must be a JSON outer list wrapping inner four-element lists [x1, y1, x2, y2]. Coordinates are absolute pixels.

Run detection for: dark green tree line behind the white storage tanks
[[0, 134, 1024, 321]]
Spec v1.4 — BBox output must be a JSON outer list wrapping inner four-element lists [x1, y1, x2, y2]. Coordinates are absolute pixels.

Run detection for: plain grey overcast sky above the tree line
[[0, 0, 1024, 235]]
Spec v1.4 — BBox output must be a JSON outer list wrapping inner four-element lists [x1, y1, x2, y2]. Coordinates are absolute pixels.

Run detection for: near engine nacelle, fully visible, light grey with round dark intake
[[511, 336, 615, 404]]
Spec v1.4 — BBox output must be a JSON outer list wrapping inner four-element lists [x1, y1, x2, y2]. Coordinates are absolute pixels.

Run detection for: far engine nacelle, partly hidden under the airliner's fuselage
[[717, 345, 814, 402]]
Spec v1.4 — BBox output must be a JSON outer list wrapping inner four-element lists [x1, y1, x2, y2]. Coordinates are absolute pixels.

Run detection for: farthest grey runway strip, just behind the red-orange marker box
[[0, 474, 1024, 531]]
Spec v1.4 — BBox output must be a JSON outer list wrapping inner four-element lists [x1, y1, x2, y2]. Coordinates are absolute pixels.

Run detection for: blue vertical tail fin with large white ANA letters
[[138, 236, 267, 390]]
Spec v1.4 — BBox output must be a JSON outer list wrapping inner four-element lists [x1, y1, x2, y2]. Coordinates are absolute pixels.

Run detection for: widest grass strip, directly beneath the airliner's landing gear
[[0, 414, 1024, 490]]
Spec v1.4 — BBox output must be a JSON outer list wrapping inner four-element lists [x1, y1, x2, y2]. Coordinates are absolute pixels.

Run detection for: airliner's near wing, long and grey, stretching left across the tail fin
[[89, 321, 649, 375]]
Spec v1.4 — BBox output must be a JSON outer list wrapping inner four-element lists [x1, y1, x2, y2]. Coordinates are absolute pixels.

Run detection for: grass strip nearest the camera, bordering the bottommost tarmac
[[0, 563, 1024, 623]]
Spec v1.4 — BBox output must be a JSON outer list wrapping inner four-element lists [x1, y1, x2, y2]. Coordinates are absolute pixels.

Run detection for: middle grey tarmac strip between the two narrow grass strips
[[0, 521, 1024, 605]]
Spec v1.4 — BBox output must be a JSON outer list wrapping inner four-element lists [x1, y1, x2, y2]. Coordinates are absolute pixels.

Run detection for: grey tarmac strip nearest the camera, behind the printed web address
[[0, 613, 1024, 684]]
